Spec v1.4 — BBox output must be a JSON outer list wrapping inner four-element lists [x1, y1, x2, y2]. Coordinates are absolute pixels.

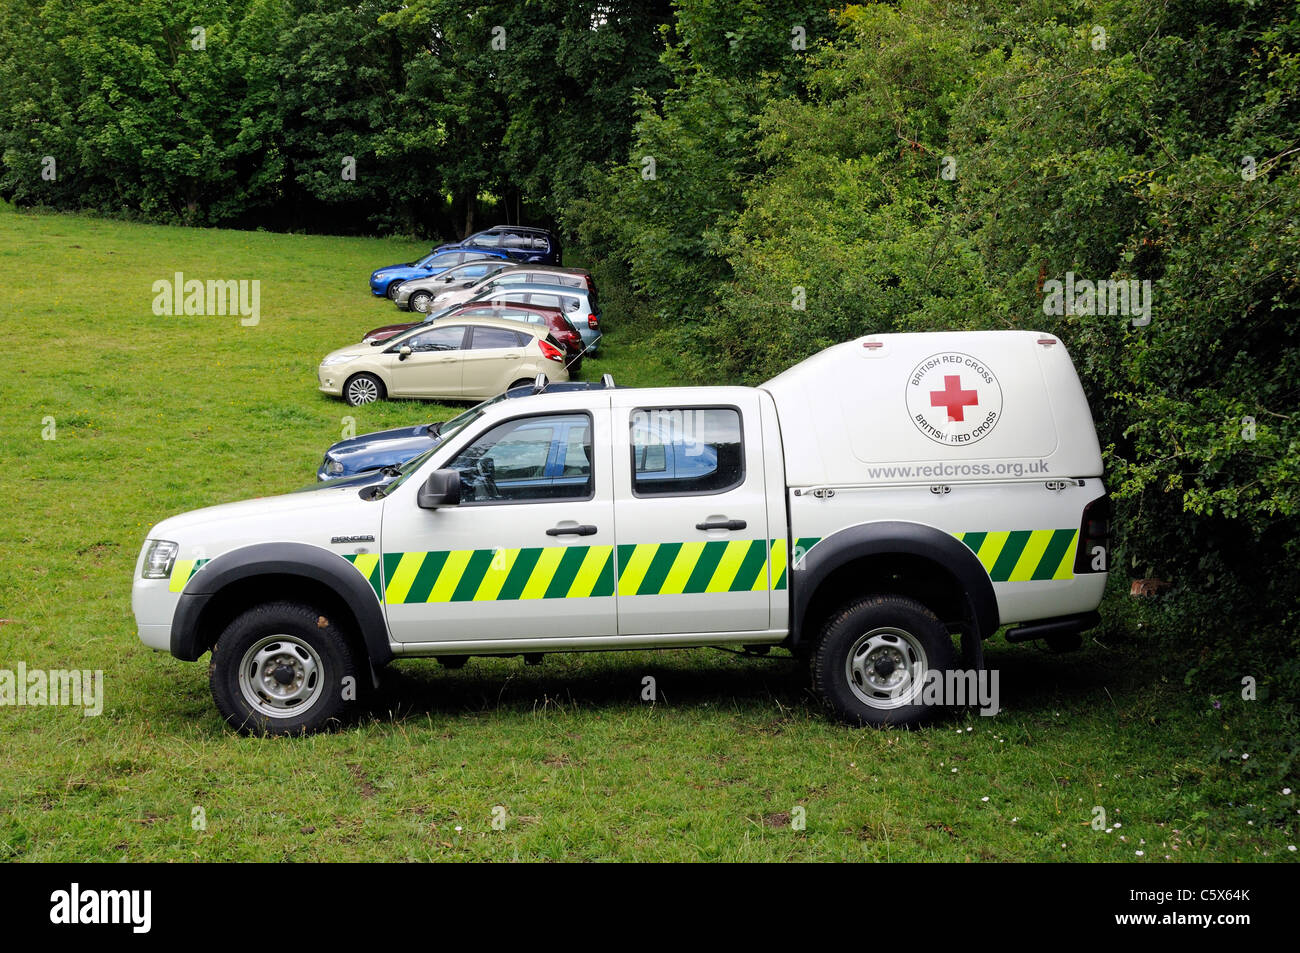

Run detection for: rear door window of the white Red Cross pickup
[[629, 407, 745, 497]]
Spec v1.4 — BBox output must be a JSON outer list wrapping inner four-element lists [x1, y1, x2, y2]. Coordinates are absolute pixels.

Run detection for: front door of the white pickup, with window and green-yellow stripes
[[382, 395, 618, 649]]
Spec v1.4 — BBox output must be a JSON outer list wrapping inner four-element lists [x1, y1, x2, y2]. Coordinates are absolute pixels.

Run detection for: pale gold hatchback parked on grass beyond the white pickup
[[317, 317, 568, 407]]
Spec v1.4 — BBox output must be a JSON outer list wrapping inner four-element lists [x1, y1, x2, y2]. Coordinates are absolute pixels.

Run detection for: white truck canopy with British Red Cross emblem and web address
[[761, 332, 1101, 486]]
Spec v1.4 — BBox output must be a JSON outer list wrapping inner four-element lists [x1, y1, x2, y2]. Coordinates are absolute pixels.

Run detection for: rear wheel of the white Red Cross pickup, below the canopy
[[811, 595, 957, 728]]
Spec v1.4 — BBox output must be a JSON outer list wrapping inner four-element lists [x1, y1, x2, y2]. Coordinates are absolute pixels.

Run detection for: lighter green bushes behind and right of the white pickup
[[582, 0, 1300, 701]]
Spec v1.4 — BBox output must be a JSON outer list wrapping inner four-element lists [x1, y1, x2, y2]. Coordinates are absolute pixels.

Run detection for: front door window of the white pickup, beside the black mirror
[[447, 413, 593, 504]]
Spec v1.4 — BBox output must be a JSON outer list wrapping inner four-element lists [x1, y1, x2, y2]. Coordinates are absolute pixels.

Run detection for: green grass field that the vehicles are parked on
[[0, 208, 1300, 863]]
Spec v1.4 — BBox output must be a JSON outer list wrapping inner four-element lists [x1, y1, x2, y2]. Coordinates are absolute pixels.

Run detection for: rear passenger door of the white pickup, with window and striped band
[[612, 391, 784, 636]]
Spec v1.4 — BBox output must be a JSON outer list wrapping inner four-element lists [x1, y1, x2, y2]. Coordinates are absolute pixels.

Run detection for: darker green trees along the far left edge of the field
[[0, 0, 670, 235]]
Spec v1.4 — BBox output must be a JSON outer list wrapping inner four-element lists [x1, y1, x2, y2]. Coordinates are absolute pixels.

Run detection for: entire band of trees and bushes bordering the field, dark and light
[[0, 0, 1300, 698]]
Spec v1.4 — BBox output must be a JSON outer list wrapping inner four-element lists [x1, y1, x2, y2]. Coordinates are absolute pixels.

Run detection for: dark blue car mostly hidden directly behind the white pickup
[[316, 380, 612, 486]]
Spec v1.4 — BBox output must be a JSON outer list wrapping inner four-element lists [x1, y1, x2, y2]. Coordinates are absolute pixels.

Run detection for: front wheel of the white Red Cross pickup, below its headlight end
[[208, 602, 361, 735]]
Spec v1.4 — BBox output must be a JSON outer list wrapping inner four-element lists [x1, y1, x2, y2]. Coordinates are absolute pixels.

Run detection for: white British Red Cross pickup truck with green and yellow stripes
[[133, 332, 1108, 733]]
